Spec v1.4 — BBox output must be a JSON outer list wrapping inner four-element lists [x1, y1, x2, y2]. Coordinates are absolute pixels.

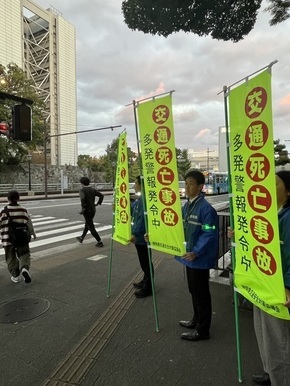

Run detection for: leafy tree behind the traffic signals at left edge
[[0, 63, 44, 164]]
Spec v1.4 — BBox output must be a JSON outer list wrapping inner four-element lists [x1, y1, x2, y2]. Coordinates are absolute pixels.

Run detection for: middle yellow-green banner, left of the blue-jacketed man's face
[[138, 95, 185, 256]]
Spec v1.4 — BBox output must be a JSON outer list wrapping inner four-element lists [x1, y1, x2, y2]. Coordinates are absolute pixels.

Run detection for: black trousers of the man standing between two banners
[[186, 267, 212, 335]]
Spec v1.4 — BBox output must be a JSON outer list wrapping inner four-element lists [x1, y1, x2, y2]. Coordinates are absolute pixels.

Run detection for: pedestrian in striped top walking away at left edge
[[0, 190, 36, 283]]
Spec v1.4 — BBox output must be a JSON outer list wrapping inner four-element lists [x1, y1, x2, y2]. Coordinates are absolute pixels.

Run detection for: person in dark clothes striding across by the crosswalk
[[77, 177, 104, 248]]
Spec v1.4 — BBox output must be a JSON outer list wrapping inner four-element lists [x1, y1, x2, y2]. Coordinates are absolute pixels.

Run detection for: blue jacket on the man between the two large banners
[[175, 194, 218, 269]]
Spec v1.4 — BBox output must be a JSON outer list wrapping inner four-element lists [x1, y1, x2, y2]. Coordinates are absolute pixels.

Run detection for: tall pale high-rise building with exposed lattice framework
[[0, 0, 78, 165]]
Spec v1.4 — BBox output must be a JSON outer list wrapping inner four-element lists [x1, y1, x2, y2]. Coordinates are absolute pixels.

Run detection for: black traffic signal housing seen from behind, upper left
[[12, 103, 32, 142]]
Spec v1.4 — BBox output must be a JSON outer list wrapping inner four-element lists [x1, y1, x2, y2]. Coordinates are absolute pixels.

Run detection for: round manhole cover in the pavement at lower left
[[0, 299, 50, 323]]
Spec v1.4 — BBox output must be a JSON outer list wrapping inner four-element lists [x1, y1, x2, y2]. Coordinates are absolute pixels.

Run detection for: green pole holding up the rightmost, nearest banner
[[223, 86, 243, 383]]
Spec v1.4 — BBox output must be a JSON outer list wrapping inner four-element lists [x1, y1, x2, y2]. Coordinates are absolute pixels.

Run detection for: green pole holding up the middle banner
[[133, 101, 159, 332]]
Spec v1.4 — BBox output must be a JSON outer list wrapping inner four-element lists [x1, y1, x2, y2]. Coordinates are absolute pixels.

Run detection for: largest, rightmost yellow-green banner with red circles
[[229, 69, 290, 319]]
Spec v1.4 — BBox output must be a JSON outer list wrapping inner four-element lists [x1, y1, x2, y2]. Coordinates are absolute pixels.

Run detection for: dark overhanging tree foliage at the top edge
[[122, 0, 290, 42]]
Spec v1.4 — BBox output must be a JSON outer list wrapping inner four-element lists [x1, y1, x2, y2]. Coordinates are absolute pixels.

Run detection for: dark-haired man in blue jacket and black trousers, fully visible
[[176, 170, 218, 341]]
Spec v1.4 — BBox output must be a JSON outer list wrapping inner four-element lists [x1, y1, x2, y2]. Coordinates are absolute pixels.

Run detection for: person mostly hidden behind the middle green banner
[[131, 176, 153, 298]]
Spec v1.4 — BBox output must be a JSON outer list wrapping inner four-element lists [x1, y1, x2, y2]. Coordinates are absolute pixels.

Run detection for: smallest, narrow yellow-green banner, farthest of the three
[[113, 132, 131, 245]]
